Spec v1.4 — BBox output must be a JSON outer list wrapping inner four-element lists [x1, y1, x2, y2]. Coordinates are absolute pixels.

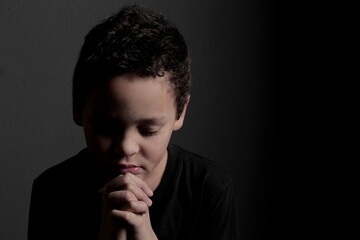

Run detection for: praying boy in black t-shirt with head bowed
[[28, 6, 238, 240]]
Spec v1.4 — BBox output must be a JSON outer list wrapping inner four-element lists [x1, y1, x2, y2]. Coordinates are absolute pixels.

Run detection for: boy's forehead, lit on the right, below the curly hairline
[[88, 74, 176, 118]]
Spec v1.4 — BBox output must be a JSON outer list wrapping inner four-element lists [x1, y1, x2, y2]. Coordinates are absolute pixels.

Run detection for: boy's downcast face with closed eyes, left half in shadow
[[74, 74, 186, 187]]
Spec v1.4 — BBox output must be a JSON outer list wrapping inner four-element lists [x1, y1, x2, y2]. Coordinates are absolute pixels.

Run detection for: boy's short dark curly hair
[[73, 6, 190, 118]]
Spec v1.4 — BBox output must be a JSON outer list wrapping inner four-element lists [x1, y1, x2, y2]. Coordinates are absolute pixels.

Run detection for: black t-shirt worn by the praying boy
[[28, 145, 239, 240]]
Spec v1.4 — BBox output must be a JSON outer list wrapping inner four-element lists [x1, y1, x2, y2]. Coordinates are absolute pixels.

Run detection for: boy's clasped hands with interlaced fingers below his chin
[[98, 173, 157, 240]]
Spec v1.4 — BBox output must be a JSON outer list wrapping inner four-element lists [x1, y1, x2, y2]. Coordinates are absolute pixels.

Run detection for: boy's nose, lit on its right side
[[113, 130, 140, 157]]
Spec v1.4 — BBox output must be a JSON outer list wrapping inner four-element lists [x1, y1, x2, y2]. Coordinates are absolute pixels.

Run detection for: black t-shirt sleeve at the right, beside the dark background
[[194, 173, 240, 240]]
